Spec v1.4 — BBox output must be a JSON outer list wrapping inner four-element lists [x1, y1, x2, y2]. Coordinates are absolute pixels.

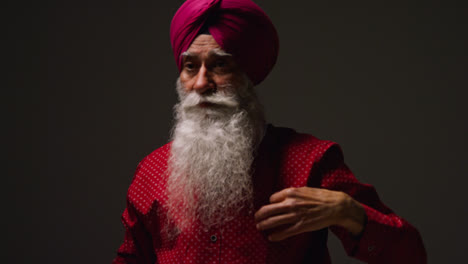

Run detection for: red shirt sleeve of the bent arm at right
[[312, 145, 427, 264]]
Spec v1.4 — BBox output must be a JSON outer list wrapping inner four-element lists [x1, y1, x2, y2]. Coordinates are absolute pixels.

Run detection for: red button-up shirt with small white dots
[[113, 125, 426, 264]]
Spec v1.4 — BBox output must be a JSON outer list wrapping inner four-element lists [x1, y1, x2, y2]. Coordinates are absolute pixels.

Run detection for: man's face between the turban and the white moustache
[[180, 34, 243, 94]]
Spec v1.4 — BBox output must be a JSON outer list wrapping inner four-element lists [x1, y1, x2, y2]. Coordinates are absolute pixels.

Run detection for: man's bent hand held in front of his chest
[[255, 187, 366, 241]]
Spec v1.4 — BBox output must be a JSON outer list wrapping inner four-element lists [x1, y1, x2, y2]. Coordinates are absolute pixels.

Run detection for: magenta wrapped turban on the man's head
[[171, 0, 279, 85]]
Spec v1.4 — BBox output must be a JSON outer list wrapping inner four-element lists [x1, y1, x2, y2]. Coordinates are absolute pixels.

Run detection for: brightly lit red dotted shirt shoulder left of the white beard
[[127, 143, 171, 212]]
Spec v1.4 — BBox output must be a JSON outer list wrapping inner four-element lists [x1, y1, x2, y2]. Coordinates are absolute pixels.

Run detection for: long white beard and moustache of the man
[[166, 79, 265, 235]]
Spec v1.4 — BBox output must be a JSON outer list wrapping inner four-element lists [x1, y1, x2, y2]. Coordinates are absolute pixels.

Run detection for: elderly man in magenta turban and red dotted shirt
[[114, 0, 426, 263]]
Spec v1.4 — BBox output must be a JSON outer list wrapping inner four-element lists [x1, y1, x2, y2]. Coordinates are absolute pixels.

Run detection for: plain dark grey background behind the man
[[5, 0, 468, 263]]
